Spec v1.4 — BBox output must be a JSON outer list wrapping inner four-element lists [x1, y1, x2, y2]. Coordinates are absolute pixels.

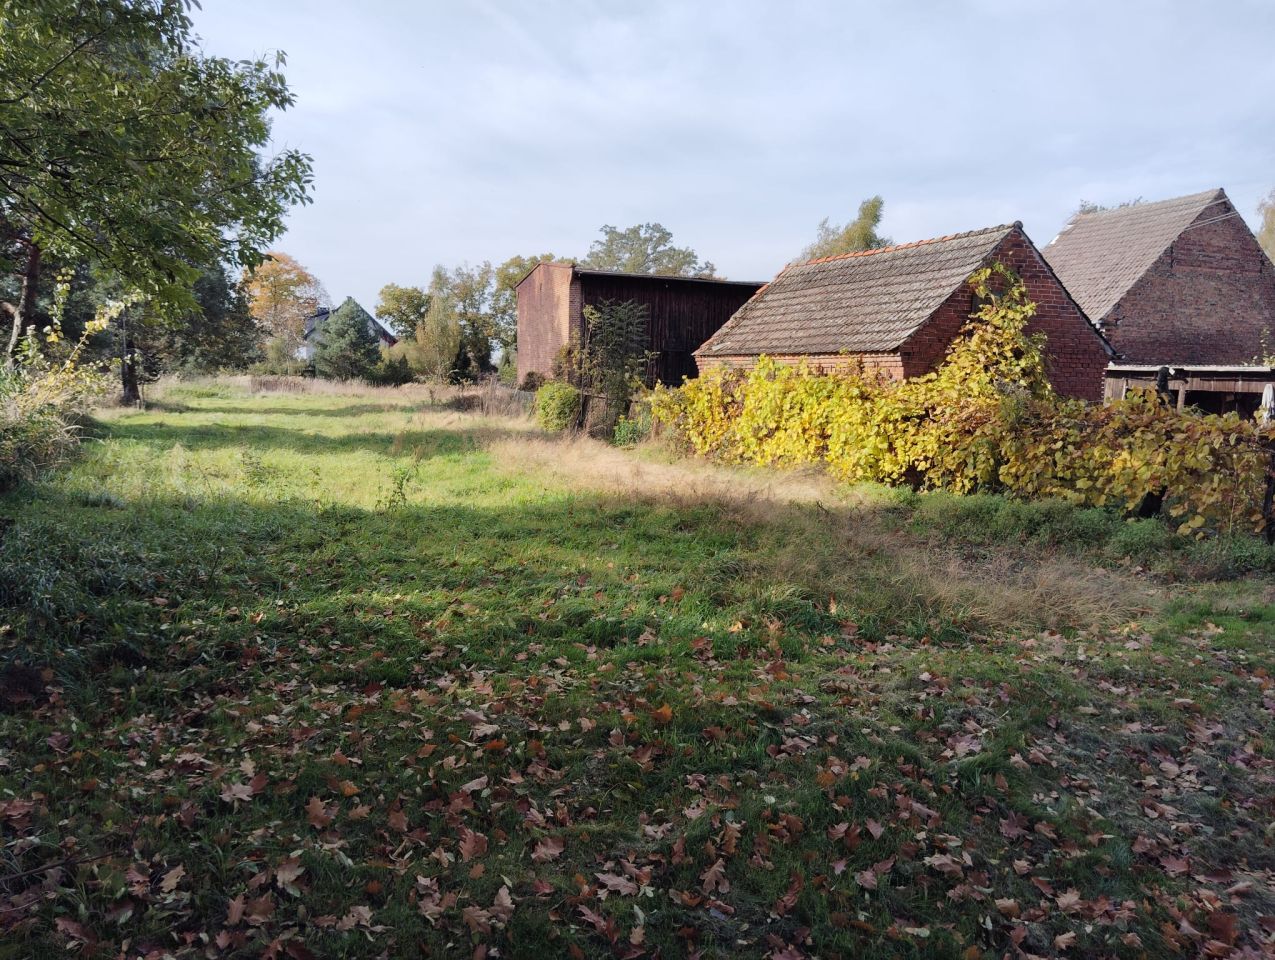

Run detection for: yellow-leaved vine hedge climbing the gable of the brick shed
[[652, 264, 1275, 538]]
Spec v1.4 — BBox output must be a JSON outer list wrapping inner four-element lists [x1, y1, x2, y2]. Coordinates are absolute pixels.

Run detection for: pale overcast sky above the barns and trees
[[194, 0, 1275, 309]]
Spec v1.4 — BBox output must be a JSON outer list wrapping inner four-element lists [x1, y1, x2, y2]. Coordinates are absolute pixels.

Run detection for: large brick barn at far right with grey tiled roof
[[1040, 190, 1275, 366]]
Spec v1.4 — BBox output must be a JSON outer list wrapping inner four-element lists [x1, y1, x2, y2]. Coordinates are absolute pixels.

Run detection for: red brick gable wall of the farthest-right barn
[[1103, 201, 1275, 363]]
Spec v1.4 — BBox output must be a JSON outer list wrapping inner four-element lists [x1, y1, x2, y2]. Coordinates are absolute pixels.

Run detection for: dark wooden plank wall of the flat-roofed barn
[[579, 273, 761, 386]]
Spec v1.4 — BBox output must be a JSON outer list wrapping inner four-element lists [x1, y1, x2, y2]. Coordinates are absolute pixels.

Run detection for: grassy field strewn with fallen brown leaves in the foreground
[[0, 385, 1275, 959]]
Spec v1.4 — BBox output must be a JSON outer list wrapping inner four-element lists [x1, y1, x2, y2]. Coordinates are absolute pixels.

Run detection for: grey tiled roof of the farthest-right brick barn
[[1040, 189, 1227, 323]]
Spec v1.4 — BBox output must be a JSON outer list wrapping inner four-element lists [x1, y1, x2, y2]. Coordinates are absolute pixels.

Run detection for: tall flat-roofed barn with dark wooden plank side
[[516, 263, 761, 385]]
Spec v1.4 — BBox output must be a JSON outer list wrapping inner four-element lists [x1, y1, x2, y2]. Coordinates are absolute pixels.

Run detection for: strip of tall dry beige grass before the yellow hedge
[[490, 435, 1158, 631]]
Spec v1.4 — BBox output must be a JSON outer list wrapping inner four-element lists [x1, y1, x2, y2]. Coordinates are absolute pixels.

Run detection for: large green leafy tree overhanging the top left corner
[[0, 0, 311, 385]]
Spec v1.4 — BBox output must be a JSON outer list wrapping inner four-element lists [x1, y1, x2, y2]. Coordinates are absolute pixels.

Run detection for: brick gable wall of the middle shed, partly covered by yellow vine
[[900, 231, 1111, 400]]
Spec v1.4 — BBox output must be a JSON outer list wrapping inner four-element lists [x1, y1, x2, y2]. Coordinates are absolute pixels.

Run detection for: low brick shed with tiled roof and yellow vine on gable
[[696, 223, 1113, 400]]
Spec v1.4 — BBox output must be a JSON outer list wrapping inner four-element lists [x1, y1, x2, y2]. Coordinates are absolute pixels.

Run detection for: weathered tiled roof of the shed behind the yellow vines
[[696, 223, 1023, 357]]
